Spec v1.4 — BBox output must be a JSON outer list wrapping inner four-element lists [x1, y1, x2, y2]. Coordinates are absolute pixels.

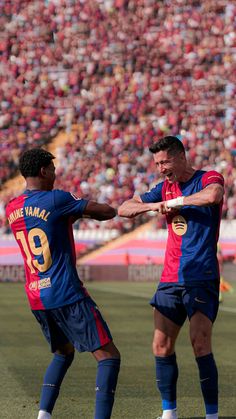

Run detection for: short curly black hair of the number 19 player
[[19, 148, 55, 178]]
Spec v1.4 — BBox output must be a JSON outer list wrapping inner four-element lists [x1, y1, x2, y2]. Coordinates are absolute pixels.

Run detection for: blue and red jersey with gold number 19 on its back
[[6, 189, 88, 310]]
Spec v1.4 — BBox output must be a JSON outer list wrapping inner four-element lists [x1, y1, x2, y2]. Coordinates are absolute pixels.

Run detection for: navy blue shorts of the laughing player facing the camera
[[150, 280, 219, 326]]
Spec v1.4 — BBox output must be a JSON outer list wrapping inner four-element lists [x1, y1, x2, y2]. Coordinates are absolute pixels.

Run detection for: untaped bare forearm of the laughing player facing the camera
[[118, 195, 165, 218]]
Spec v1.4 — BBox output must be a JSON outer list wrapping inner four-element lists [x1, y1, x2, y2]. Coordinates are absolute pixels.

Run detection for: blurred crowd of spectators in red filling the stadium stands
[[0, 0, 236, 232]]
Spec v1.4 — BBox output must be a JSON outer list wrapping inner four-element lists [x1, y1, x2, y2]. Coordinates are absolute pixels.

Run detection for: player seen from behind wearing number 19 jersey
[[6, 148, 120, 419]]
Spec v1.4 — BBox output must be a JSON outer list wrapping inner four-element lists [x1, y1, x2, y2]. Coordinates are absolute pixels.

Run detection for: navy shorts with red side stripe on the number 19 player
[[32, 297, 112, 352]]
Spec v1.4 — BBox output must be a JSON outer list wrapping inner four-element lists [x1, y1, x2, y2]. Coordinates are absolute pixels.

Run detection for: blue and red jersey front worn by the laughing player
[[141, 170, 224, 283]]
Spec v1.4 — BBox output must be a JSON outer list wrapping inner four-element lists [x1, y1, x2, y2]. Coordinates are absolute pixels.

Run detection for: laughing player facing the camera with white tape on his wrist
[[118, 136, 224, 419]]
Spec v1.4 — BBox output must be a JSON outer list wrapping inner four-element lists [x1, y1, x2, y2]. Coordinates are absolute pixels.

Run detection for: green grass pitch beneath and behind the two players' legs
[[0, 282, 236, 419]]
